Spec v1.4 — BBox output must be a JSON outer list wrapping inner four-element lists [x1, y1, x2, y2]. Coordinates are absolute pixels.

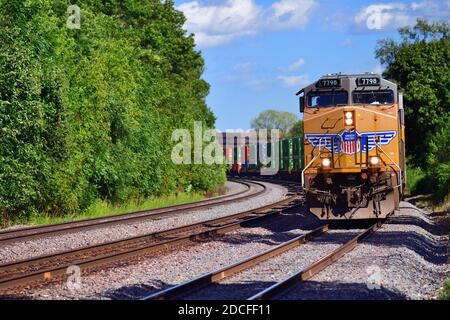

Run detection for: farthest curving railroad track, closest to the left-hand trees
[[0, 179, 266, 245]]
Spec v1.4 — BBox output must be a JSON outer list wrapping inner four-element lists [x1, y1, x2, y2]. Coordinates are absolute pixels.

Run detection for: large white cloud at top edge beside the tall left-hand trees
[[177, 0, 317, 47]]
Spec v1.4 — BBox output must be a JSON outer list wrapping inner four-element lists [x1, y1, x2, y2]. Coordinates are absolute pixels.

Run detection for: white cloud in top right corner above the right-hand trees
[[354, 0, 450, 30]]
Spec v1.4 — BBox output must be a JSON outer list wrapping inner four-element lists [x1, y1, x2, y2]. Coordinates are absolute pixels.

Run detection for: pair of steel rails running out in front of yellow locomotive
[[143, 222, 381, 300]]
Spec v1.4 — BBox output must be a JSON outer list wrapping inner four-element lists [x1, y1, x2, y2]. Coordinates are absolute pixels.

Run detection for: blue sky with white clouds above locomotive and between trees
[[175, 0, 450, 131]]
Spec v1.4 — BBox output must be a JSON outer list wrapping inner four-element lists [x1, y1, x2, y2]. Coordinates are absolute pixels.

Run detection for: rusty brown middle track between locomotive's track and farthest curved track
[[0, 191, 301, 295]]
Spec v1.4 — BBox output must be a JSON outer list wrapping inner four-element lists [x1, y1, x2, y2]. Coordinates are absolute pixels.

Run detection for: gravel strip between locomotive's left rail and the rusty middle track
[[11, 205, 318, 299]]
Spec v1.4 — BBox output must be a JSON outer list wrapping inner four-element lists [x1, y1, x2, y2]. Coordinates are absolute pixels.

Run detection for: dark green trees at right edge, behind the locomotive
[[376, 19, 450, 199]]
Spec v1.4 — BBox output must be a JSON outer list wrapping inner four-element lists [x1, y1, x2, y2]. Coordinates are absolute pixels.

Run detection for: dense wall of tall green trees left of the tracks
[[0, 0, 225, 222]]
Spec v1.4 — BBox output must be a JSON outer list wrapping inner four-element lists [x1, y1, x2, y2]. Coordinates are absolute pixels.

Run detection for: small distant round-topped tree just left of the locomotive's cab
[[251, 110, 303, 138]]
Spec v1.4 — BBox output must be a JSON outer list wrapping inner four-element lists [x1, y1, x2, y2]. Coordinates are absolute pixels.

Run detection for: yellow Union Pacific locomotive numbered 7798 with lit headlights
[[297, 73, 405, 220]]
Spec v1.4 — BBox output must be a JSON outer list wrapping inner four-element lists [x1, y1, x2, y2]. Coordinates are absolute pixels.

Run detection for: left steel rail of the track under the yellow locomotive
[[141, 225, 328, 300]]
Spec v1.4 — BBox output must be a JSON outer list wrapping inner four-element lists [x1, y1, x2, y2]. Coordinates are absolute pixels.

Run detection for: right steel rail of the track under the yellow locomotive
[[248, 222, 381, 300]]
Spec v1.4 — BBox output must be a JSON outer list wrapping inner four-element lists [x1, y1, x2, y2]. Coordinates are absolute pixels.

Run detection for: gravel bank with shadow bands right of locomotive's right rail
[[279, 202, 449, 300]]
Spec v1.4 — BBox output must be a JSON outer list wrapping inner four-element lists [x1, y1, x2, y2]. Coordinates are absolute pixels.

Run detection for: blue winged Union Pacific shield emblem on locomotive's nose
[[305, 130, 397, 154]]
